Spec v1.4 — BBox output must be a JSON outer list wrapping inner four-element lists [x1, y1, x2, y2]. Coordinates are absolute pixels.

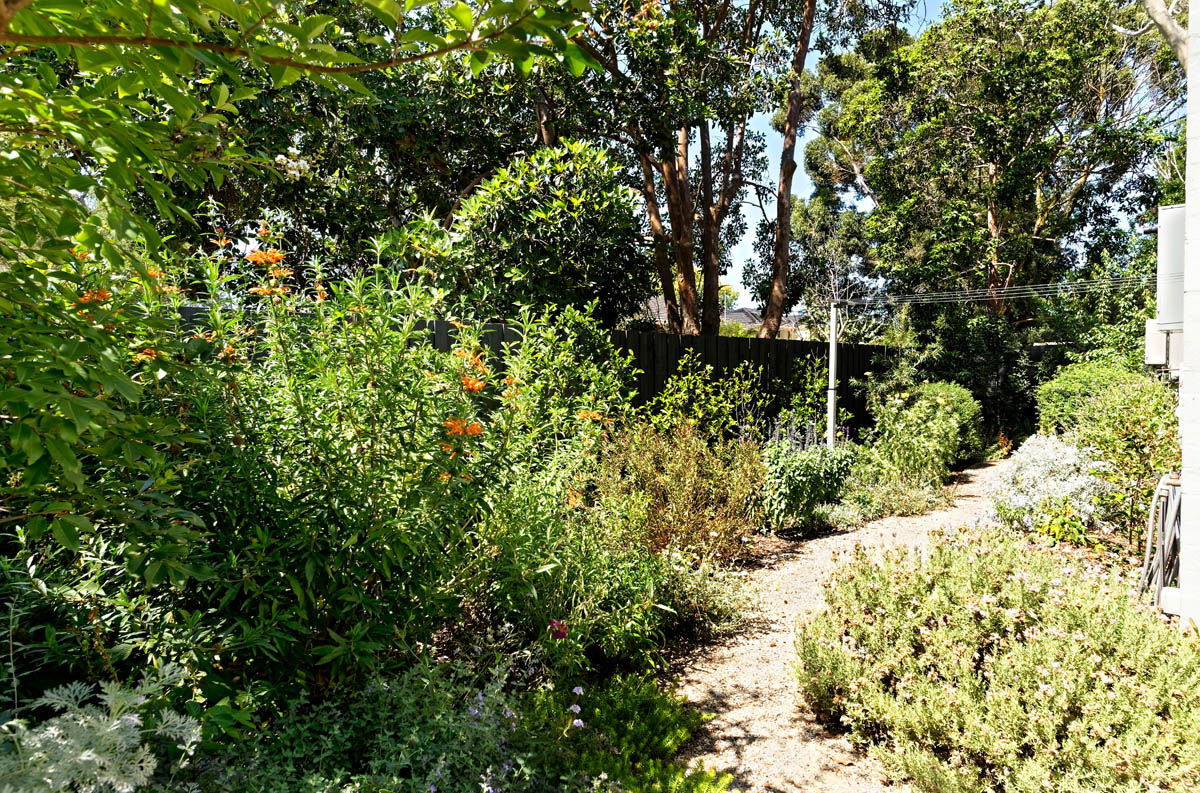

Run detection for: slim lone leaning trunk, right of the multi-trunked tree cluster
[[758, 0, 817, 338]]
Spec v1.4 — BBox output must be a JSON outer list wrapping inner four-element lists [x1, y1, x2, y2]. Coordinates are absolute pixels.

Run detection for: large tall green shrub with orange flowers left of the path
[[9, 256, 649, 710]]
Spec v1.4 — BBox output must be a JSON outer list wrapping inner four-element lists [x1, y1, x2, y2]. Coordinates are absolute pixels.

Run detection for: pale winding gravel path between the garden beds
[[679, 462, 1006, 793]]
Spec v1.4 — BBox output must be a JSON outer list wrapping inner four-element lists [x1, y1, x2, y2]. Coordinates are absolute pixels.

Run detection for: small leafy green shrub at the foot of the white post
[[762, 441, 854, 529]]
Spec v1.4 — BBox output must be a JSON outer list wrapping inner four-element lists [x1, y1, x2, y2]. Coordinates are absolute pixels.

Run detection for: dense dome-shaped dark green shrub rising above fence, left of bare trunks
[[431, 140, 654, 326]]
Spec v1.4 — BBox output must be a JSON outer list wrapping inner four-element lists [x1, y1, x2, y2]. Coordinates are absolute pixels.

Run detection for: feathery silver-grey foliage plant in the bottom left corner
[[0, 667, 200, 793]]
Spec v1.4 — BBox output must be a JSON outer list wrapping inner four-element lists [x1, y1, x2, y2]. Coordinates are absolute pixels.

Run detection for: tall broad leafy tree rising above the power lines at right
[[810, 0, 1180, 303]]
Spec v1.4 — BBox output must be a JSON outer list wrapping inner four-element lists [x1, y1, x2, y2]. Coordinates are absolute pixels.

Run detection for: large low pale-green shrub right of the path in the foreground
[[797, 525, 1200, 793]]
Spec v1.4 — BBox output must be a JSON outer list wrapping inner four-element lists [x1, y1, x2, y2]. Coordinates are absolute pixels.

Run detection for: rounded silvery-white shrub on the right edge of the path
[[990, 435, 1111, 542]]
